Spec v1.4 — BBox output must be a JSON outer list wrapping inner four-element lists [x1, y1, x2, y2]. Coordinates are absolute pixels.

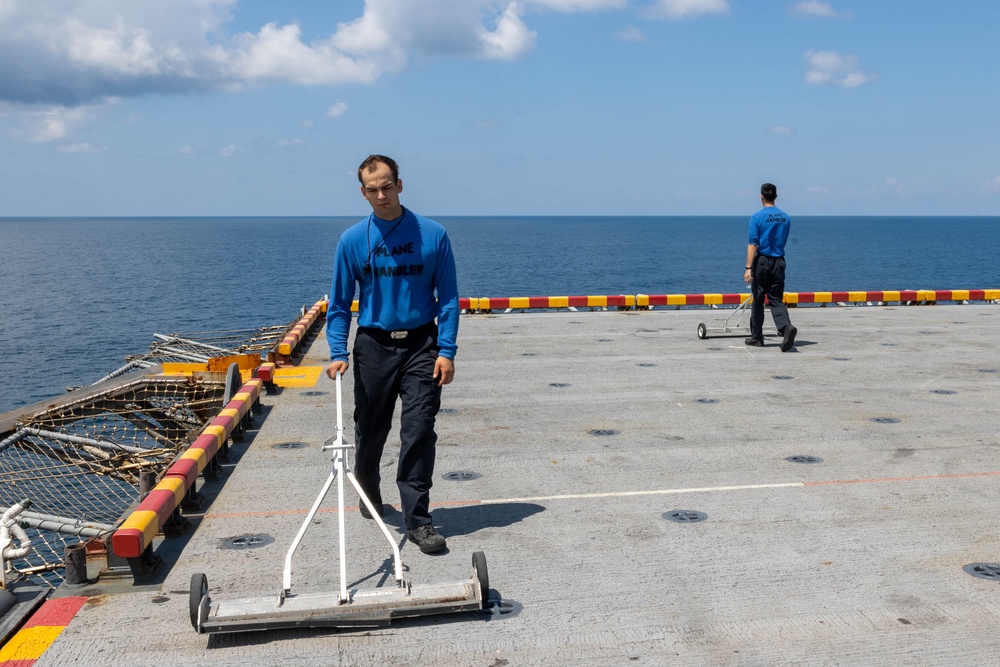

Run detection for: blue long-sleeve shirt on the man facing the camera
[[326, 208, 459, 361]]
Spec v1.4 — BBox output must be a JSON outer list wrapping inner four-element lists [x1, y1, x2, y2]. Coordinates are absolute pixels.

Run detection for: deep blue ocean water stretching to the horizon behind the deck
[[0, 214, 1000, 413]]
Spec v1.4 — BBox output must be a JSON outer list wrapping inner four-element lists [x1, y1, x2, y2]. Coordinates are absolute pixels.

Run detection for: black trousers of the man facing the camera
[[354, 322, 441, 530]]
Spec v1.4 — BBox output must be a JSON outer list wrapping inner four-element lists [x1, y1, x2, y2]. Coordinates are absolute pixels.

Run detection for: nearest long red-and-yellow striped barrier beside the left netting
[[111, 378, 264, 558]]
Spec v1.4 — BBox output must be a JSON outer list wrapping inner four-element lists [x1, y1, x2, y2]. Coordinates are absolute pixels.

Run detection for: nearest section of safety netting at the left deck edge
[[0, 375, 227, 587]]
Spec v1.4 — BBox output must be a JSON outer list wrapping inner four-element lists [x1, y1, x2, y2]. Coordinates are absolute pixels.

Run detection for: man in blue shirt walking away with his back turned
[[743, 183, 798, 352]]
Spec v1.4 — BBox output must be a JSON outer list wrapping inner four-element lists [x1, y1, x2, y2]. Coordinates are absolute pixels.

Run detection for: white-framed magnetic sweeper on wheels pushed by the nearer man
[[189, 373, 490, 633]]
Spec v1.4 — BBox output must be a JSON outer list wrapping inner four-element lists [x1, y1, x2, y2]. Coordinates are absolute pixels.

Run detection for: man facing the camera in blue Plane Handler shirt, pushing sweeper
[[326, 155, 459, 553]]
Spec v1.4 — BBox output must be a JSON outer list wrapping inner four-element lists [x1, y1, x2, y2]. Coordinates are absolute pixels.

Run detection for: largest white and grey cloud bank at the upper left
[[0, 0, 548, 107]]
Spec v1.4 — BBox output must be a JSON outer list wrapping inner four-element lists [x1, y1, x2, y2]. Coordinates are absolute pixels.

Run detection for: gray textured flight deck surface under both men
[[36, 303, 1000, 667]]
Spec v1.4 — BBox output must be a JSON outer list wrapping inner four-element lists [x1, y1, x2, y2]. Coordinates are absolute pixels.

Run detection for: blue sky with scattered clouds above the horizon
[[0, 0, 1000, 217]]
